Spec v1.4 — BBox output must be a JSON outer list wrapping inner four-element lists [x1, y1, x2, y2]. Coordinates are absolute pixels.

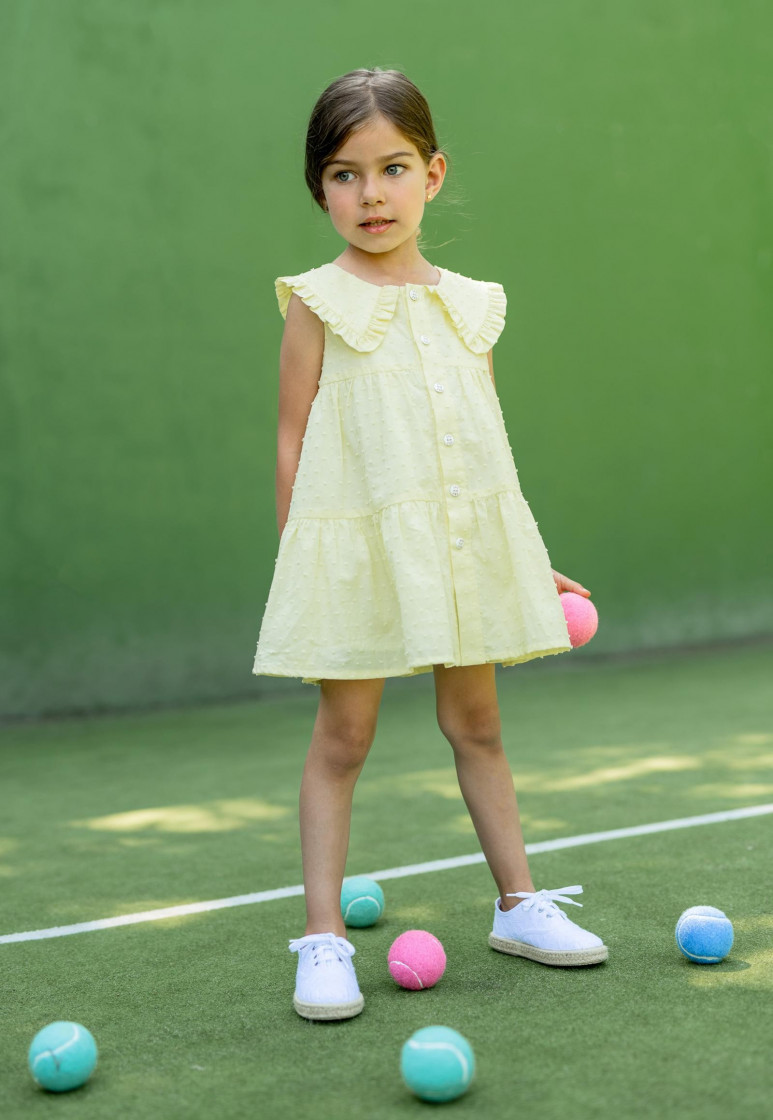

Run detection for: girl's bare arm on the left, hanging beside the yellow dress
[[277, 292, 325, 539]]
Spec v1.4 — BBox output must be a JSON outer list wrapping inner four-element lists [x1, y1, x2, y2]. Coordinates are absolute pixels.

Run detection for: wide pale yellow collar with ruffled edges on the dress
[[274, 262, 507, 354]]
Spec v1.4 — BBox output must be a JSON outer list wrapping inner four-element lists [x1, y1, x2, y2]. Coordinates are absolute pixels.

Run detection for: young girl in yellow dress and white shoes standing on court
[[252, 68, 607, 1019]]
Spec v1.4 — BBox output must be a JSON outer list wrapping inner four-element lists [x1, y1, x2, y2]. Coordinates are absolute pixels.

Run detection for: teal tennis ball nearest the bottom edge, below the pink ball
[[400, 1027, 475, 1101]]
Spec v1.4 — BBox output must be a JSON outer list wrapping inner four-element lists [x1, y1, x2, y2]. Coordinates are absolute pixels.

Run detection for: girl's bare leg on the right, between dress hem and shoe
[[434, 665, 534, 911]]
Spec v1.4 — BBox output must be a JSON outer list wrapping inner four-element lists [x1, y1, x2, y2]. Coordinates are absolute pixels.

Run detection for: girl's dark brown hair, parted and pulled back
[[306, 66, 447, 209]]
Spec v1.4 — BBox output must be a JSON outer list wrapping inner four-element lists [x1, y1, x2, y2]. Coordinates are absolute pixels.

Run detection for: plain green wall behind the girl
[[0, 0, 773, 716]]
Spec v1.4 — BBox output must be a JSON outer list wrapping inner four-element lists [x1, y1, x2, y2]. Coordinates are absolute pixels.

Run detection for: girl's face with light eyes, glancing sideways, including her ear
[[323, 115, 446, 253]]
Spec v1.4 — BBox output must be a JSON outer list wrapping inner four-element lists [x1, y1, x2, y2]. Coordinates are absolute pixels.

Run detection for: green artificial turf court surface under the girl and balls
[[0, 647, 773, 1120]]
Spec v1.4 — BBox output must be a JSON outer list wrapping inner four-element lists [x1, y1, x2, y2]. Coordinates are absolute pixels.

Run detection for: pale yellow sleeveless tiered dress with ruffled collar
[[252, 263, 571, 684]]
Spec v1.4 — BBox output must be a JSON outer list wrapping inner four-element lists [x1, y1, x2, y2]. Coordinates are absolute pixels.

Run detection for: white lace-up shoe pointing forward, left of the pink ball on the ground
[[285, 933, 365, 1019]]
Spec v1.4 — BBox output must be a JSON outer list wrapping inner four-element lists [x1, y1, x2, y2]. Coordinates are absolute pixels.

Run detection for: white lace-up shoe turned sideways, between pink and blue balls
[[488, 886, 608, 967]]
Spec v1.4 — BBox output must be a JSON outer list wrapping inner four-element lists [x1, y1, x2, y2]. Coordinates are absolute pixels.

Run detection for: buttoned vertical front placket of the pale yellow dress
[[406, 289, 486, 665]]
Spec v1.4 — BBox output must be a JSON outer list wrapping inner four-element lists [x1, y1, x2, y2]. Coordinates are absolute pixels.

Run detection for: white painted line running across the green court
[[0, 804, 773, 945]]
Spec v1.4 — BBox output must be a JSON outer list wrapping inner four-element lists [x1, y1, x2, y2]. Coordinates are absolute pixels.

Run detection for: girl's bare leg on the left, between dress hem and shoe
[[299, 678, 384, 936]]
